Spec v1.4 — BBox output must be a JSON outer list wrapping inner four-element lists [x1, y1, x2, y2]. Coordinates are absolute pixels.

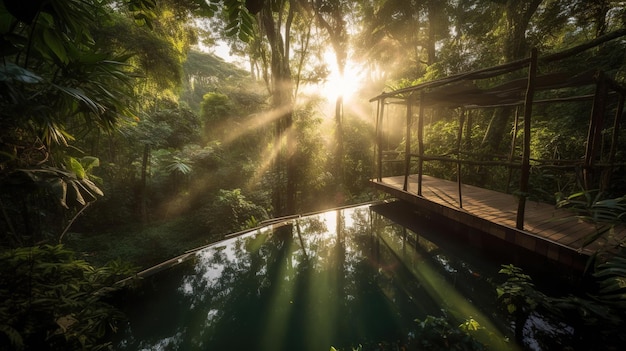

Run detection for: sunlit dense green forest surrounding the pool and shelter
[[0, 0, 626, 350]]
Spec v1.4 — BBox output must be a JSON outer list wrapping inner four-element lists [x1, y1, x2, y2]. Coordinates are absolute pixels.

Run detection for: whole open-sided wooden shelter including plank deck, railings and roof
[[371, 51, 626, 270]]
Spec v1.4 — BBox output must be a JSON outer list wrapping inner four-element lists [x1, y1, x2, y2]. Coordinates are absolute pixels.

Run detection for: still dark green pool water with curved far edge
[[115, 204, 518, 351]]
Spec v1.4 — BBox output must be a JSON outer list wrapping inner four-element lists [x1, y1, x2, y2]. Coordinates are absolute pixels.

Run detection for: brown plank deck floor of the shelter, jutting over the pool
[[372, 175, 626, 264]]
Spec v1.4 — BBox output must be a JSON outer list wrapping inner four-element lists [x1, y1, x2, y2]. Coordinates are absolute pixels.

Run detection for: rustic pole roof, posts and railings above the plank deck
[[370, 50, 626, 230]]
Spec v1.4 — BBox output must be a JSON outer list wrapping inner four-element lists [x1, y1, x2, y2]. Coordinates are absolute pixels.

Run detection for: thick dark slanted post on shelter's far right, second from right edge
[[583, 72, 606, 190]]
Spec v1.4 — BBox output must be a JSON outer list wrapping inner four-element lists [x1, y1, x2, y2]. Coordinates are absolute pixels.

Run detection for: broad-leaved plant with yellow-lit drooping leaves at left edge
[[0, 156, 104, 247]]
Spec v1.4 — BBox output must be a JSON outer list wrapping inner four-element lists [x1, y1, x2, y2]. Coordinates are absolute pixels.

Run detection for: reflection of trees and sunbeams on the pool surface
[[117, 208, 446, 350]]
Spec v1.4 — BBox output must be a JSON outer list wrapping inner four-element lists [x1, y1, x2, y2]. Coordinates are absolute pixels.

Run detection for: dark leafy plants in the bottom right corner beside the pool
[[496, 264, 626, 350]]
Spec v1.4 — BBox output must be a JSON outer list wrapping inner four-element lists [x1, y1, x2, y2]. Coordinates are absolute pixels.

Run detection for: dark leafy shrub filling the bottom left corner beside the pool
[[0, 245, 132, 350]]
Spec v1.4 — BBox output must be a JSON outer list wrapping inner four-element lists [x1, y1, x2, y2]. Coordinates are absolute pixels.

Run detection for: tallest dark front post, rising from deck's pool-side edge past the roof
[[516, 48, 537, 229]]
